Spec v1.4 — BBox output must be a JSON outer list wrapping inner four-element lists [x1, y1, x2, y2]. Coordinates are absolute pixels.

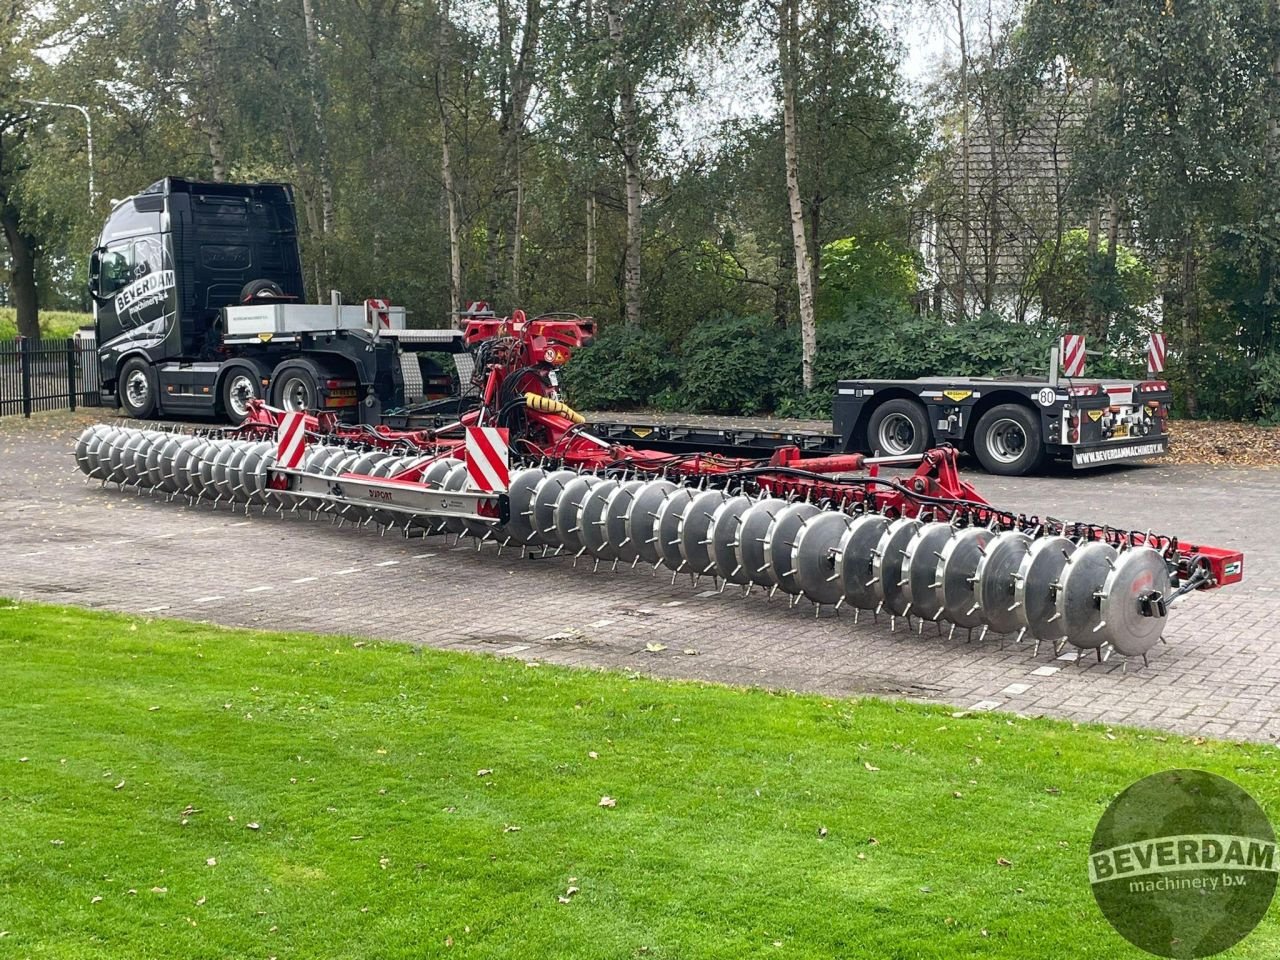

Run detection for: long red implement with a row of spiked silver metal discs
[[76, 311, 1243, 660]]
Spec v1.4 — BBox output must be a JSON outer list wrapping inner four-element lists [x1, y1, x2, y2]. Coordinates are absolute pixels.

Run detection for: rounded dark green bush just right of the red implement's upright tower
[[562, 324, 676, 410]]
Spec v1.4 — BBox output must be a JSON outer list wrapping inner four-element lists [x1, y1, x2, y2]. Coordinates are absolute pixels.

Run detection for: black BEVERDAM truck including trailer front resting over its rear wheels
[[90, 177, 462, 424]]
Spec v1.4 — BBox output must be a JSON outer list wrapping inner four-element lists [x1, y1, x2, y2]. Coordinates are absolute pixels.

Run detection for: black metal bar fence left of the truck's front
[[0, 337, 101, 417]]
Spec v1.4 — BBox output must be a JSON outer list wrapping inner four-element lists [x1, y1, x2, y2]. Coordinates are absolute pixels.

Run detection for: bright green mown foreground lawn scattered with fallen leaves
[[0, 602, 1280, 960]]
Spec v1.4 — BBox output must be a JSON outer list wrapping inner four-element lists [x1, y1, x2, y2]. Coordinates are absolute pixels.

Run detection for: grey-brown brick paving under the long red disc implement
[[0, 415, 1280, 741]]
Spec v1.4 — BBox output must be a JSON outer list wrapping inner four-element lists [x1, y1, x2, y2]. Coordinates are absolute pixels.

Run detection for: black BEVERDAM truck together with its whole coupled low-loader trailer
[[90, 177, 1172, 475]]
